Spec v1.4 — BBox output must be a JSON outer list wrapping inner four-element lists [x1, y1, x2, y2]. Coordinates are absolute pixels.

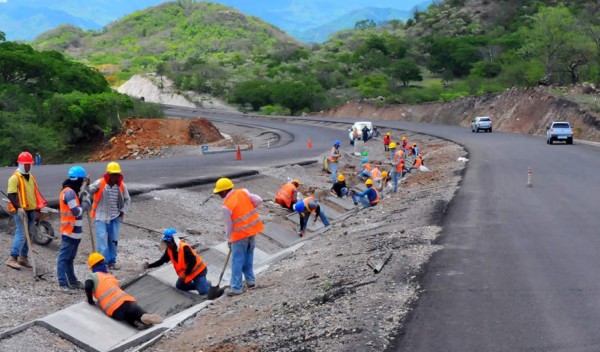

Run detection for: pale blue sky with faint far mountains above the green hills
[[0, 0, 432, 40]]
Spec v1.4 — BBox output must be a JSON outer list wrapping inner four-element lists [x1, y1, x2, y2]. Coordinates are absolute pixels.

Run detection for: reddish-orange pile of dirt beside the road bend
[[89, 119, 223, 161]]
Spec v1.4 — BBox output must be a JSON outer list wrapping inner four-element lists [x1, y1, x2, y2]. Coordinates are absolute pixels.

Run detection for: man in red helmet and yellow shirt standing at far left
[[6, 152, 46, 270]]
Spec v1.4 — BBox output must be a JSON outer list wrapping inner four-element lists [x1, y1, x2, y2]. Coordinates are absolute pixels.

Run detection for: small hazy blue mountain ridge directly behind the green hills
[[290, 7, 412, 43]]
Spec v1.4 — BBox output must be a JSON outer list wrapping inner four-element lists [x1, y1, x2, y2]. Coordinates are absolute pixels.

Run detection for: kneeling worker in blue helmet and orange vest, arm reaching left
[[144, 228, 210, 295]]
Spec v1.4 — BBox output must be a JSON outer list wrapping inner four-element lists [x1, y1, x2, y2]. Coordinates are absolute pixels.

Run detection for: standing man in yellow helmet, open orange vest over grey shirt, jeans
[[88, 161, 131, 270]]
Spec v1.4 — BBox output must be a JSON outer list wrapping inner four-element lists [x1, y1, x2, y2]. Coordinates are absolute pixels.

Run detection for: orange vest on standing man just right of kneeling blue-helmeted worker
[[223, 189, 264, 242]]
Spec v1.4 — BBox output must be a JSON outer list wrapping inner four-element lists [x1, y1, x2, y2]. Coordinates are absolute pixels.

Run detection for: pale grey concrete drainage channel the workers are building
[[0, 176, 370, 352]]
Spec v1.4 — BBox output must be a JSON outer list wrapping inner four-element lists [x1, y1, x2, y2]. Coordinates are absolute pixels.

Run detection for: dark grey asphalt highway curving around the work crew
[[0, 108, 600, 352]]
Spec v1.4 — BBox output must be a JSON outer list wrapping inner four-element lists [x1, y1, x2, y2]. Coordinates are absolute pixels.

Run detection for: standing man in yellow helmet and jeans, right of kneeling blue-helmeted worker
[[213, 178, 264, 296]]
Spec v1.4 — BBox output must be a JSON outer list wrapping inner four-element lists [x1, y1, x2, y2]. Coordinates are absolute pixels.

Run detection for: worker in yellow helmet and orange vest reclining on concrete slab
[[85, 253, 163, 329]]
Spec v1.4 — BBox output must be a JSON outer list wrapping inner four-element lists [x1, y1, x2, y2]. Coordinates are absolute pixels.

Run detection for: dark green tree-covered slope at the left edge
[[0, 32, 162, 165]]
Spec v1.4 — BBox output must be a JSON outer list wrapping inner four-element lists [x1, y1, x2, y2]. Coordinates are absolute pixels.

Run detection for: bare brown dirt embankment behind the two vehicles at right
[[317, 88, 600, 142]]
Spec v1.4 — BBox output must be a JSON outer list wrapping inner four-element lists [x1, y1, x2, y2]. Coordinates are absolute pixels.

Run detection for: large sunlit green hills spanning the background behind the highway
[[29, 0, 600, 114]]
